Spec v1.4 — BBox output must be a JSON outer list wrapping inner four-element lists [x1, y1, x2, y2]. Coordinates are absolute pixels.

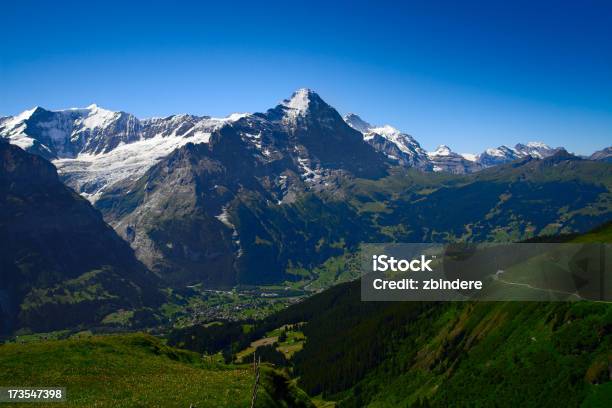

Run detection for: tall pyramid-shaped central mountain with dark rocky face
[[96, 90, 387, 286]]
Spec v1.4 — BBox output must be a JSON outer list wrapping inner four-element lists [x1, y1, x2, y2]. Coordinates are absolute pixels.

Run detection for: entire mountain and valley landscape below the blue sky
[[0, 89, 612, 408]]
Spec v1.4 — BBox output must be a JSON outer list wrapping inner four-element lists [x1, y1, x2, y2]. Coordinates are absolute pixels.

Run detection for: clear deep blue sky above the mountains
[[0, 0, 612, 153]]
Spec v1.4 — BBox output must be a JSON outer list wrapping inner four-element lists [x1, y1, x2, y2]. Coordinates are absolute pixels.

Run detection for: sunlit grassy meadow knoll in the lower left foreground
[[0, 334, 309, 408]]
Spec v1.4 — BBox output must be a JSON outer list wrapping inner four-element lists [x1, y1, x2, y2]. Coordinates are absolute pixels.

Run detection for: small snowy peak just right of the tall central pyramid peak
[[344, 113, 433, 171]]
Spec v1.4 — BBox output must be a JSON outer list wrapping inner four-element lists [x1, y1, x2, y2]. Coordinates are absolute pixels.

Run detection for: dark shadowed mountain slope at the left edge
[[0, 141, 161, 332]]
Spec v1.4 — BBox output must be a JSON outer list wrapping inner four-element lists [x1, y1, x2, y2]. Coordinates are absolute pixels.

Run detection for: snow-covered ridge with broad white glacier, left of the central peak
[[0, 105, 251, 201]]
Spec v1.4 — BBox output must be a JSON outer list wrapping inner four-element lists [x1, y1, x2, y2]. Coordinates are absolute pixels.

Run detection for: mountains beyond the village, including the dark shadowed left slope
[[0, 89, 612, 333]]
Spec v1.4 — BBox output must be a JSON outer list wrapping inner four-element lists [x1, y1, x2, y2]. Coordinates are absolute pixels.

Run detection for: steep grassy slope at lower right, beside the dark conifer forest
[[337, 302, 612, 407]]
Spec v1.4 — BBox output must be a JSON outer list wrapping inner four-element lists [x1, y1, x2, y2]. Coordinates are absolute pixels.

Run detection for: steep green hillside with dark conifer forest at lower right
[[294, 224, 612, 407]]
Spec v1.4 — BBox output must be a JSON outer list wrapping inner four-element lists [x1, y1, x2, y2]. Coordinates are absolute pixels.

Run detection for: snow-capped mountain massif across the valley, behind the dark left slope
[[0, 89, 609, 287]]
